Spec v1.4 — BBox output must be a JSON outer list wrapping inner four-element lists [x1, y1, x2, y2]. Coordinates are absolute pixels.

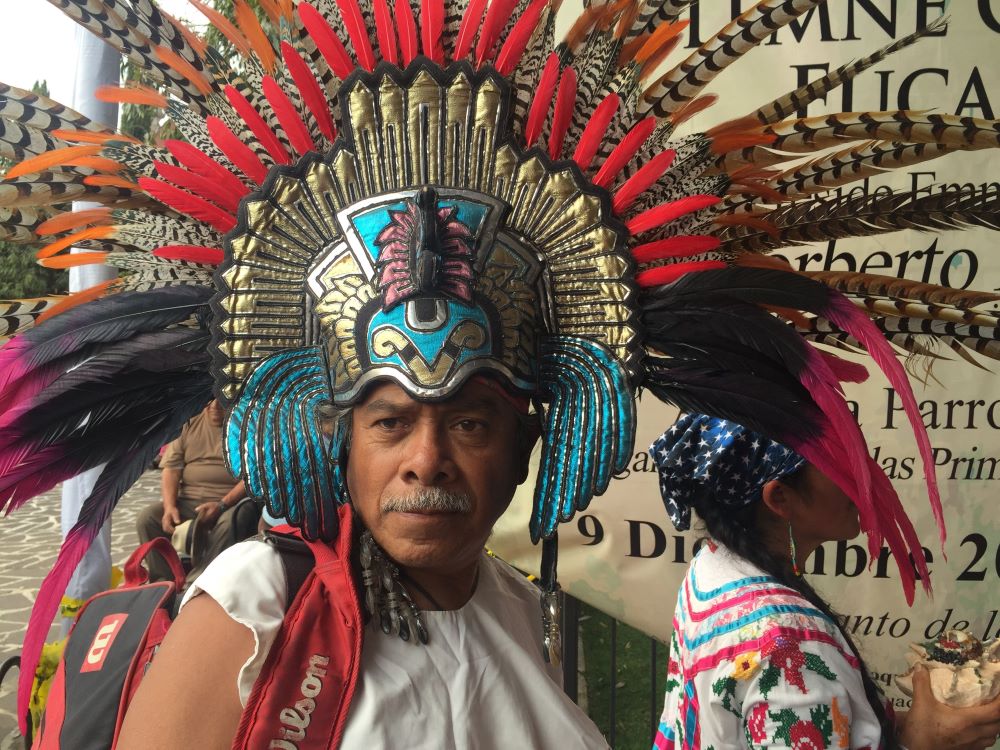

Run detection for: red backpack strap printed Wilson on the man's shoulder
[[233, 506, 363, 750]]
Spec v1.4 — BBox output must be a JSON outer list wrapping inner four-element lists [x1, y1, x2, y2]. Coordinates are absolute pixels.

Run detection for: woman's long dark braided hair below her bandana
[[693, 469, 899, 750]]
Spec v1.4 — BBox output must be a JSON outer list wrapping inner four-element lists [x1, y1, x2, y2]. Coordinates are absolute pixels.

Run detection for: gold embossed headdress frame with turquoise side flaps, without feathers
[[214, 58, 641, 539]]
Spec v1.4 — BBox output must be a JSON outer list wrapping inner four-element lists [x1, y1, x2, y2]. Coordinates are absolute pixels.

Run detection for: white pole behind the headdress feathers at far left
[[62, 26, 121, 635]]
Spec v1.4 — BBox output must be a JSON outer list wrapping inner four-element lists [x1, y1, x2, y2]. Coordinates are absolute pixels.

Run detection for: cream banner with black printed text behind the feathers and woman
[[491, 0, 1000, 720]]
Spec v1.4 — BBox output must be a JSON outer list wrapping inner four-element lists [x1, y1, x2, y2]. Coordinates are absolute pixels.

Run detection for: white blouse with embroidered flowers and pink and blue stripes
[[653, 547, 882, 750]]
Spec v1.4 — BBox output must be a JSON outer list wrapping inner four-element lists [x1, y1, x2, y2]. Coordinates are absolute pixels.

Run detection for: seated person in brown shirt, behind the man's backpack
[[136, 399, 246, 581]]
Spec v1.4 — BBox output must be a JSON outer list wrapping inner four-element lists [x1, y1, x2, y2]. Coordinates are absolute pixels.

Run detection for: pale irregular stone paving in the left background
[[0, 471, 160, 750]]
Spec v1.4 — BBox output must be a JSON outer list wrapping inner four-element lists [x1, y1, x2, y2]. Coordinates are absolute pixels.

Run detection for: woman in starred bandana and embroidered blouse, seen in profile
[[650, 415, 1000, 750]]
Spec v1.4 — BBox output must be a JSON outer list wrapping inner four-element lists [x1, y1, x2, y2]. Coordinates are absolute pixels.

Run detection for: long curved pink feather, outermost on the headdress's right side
[[822, 290, 947, 547]]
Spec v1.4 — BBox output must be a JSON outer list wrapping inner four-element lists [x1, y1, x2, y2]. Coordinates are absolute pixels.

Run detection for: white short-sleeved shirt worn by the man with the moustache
[[182, 541, 608, 750]]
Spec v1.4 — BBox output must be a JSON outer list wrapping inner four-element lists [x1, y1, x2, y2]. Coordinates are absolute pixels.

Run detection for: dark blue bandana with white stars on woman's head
[[649, 414, 806, 531]]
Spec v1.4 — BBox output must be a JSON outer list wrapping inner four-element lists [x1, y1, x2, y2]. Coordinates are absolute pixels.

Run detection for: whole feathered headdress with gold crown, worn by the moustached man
[[0, 0, 1000, 728]]
